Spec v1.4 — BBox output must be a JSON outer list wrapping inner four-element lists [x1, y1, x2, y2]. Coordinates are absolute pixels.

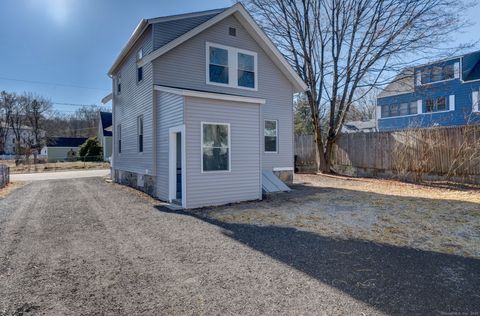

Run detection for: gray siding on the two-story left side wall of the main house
[[113, 27, 153, 174]]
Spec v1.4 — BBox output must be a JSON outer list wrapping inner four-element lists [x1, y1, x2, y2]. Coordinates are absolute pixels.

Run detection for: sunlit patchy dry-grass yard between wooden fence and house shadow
[[202, 175, 480, 258]]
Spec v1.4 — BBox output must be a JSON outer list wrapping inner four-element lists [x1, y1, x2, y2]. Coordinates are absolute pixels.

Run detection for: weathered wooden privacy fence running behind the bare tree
[[295, 126, 480, 183]]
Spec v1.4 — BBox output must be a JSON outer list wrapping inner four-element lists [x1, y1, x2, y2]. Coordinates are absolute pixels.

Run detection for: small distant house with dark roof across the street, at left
[[40, 137, 87, 162]]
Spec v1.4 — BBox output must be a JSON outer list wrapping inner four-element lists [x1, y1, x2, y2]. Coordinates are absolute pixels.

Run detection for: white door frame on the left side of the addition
[[168, 125, 187, 208]]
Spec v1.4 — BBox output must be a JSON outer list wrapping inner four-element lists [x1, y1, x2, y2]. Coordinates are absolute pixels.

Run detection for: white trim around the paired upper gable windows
[[205, 42, 258, 91]]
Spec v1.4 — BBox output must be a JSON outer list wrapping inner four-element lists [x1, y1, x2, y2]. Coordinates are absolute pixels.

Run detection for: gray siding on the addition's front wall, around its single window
[[185, 97, 262, 208]]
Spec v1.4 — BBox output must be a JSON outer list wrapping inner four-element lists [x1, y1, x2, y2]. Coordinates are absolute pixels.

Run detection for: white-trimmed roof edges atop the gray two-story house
[[108, 3, 307, 92]]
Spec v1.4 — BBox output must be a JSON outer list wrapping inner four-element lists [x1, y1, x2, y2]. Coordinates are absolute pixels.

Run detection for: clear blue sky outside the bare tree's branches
[[0, 0, 480, 114]]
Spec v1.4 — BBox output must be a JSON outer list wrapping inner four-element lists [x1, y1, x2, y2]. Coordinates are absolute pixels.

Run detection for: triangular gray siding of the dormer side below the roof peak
[[153, 13, 217, 50]]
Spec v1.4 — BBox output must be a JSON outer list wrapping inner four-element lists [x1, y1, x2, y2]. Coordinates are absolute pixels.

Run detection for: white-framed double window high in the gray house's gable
[[207, 43, 258, 90]]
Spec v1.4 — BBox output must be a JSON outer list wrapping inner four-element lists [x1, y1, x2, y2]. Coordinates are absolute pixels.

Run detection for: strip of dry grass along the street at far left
[[1, 160, 110, 173]]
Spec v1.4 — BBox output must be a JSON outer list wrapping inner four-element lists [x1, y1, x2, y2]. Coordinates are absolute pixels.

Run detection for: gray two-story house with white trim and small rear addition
[[103, 4, 306, 208]]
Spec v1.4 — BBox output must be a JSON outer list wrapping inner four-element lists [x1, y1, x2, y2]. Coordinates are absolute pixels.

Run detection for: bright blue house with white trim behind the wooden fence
[[377, 51, 480, 131]]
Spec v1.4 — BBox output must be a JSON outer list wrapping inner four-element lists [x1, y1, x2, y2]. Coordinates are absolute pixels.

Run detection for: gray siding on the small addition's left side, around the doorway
[[155, 91, 184, 201]]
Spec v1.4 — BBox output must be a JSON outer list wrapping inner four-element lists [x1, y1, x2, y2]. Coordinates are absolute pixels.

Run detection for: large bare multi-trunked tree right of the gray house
[[244, 0, 473, 172]]
